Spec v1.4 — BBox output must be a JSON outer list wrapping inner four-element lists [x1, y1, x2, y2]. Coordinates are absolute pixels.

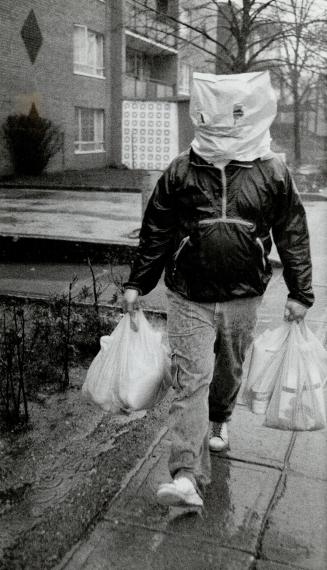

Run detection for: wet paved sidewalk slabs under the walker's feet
[[56, 382, 327, 570]]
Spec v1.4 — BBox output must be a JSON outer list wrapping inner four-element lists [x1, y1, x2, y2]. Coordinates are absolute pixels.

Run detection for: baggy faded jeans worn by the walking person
[[167, 289, 261, 490]]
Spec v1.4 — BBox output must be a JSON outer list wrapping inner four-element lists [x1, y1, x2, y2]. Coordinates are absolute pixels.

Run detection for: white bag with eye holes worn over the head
[[190, 71, 277, 164]]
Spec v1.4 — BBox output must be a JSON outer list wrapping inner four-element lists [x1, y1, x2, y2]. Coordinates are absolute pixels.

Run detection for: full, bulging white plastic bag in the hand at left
[[82, 310, 171, 413]]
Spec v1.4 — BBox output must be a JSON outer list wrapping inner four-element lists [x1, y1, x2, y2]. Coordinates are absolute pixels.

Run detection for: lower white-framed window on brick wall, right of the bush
[[75, 107, 104, 154]]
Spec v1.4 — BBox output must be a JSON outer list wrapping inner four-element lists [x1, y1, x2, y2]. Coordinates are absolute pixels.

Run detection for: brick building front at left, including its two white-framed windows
[[0, 0, 111, 172]]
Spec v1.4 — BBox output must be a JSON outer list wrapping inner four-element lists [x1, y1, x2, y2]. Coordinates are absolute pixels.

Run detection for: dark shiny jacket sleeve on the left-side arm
[[124, 168, 176, 295]]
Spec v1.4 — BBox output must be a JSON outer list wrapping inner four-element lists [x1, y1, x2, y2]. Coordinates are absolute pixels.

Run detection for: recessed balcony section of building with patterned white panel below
[[116, 0, 192, 169]]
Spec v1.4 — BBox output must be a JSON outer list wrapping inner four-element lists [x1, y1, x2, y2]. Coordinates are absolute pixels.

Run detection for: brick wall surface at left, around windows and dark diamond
[[0, 0, 110, 173]]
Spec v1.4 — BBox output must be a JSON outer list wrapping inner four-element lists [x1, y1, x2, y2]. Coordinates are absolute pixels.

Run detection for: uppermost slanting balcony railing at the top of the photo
[[125, 0, 177, 49]]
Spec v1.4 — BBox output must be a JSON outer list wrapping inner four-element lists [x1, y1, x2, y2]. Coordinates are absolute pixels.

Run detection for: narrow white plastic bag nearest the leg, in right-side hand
[[243, 323, 290, 414]]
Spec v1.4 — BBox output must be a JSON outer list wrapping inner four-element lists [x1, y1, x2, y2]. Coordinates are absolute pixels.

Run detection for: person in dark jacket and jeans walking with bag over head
[[123, 72, 314, 507]]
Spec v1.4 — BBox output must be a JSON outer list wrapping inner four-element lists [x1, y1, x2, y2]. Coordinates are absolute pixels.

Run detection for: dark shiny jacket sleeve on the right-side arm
[[272, 168, 314, 307]]
